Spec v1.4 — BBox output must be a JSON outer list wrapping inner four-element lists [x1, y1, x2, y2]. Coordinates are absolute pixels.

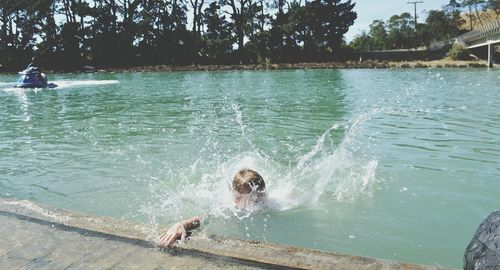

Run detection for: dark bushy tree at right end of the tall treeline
[[270, 0, 357, 62]]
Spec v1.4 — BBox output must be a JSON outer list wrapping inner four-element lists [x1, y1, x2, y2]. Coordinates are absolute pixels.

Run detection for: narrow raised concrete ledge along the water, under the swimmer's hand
[[0, 198, 441, 269]]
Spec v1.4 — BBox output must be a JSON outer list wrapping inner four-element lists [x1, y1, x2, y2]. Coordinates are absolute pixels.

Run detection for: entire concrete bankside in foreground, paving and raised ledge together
[[0, 199, 446, 269]]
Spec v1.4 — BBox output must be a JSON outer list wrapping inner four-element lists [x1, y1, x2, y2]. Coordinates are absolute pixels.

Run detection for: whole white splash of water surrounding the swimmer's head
[[142, 103, 380, 228]]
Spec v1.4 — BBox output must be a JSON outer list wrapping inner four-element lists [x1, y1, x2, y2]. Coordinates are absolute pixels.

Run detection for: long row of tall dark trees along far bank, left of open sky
[[0, 0, 356, 70]]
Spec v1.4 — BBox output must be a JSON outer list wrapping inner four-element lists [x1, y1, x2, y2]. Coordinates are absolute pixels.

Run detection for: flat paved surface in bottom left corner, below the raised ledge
[[0, 212, 282, 269]]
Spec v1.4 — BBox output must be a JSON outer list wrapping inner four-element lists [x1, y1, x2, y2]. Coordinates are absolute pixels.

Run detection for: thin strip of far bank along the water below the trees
[[0, 58, 492, 75]]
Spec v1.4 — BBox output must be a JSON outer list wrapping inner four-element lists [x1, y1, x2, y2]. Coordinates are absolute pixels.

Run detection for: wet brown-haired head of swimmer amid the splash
[[233, 169, 266, 208]]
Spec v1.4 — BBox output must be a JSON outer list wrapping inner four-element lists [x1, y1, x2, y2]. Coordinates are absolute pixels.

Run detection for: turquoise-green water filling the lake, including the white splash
[[0, 69, 500, 268]]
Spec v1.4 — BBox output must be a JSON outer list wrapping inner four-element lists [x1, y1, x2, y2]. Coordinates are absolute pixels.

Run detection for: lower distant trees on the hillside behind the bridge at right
[[349, 0, 500, 51]]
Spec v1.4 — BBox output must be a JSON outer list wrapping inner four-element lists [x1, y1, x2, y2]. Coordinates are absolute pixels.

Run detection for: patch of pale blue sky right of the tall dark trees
[[345, 0, 450, 42]]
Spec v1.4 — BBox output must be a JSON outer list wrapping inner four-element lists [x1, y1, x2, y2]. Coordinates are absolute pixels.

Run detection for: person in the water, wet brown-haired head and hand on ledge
[[158, 169, 267, 247]]
